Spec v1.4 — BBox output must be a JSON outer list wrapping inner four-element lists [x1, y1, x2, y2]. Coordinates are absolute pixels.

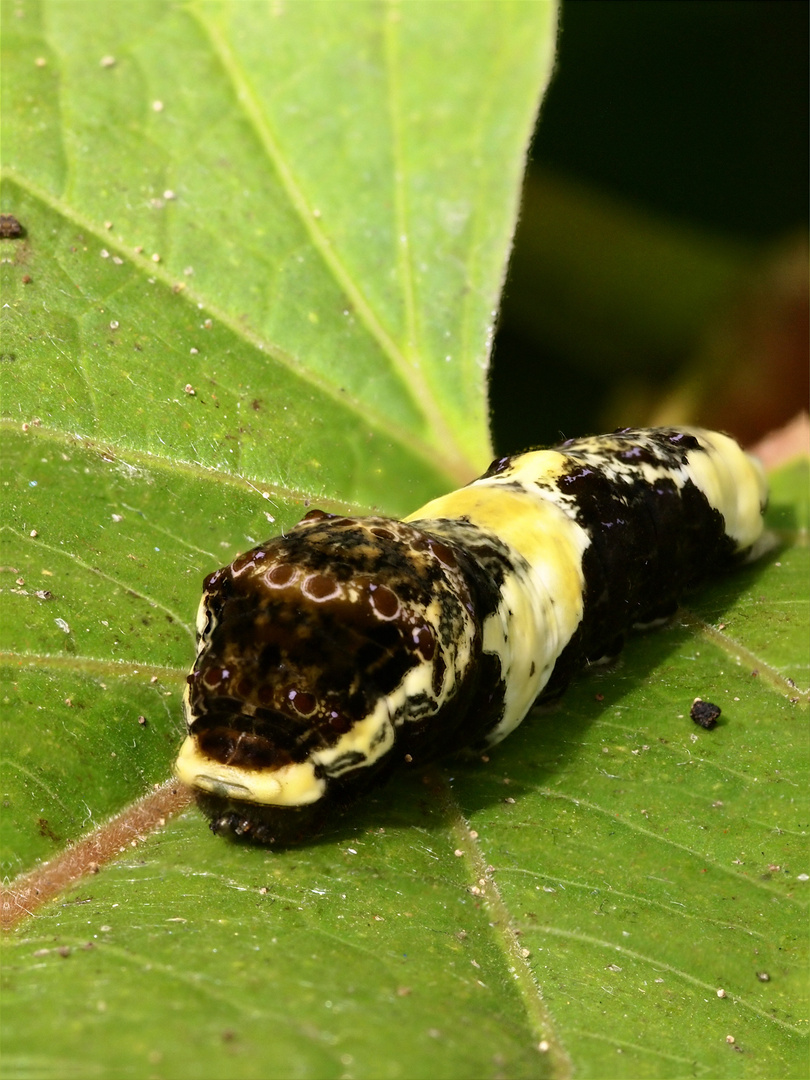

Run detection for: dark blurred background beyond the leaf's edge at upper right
[[491, 0, 810, 453]]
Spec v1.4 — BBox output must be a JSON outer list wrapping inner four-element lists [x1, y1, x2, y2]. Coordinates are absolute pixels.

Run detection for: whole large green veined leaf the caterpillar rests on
[[0, 0, 808, 1078]]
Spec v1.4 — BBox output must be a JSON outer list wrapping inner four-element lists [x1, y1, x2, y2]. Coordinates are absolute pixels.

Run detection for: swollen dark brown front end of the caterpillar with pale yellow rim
[[176, 511, 488, 842]]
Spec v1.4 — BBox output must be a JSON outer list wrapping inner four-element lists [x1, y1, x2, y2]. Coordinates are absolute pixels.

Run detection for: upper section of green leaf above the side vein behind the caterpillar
[[3, 2, 554, 496]]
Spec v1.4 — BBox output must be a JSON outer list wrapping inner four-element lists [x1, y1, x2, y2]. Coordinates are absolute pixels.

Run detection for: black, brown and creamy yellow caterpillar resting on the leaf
[[175, 428, 767, 843]]
